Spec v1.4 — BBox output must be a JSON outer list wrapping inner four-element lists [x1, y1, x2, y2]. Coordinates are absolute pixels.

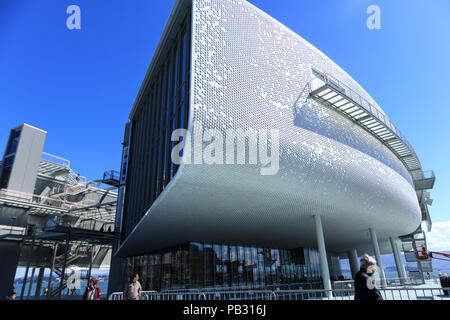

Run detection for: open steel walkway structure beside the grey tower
[[0, 153, 118, 299]]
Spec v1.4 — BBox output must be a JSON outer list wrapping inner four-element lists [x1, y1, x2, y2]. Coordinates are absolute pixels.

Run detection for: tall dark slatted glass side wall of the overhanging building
[[121, 11, 191, 241]]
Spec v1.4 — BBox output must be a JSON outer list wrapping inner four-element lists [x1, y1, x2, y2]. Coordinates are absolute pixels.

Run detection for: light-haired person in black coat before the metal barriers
[[355, 254, 383, 300]]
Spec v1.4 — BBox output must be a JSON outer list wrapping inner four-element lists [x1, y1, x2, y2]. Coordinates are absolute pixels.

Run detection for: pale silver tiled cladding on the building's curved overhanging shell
[[119, 0, 420, 255]]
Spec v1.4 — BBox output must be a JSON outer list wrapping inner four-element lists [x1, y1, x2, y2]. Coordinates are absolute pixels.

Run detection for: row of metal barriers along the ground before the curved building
[[109, 287, 450, 301]]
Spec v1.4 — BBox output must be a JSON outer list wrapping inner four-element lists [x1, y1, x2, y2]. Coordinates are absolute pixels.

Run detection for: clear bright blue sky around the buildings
[[0, 0, 450, 244]]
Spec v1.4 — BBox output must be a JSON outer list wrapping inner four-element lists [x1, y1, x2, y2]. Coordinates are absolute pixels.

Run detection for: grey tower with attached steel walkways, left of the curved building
[[0, 124, 119, 299]]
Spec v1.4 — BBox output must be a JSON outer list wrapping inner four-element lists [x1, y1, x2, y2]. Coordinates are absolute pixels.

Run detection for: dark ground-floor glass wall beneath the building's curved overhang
[[126, 242, 340, 291]]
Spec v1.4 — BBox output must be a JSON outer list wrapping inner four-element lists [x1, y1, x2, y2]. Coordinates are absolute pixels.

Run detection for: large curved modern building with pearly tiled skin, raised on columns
[[107, 0, 435, 291]]
